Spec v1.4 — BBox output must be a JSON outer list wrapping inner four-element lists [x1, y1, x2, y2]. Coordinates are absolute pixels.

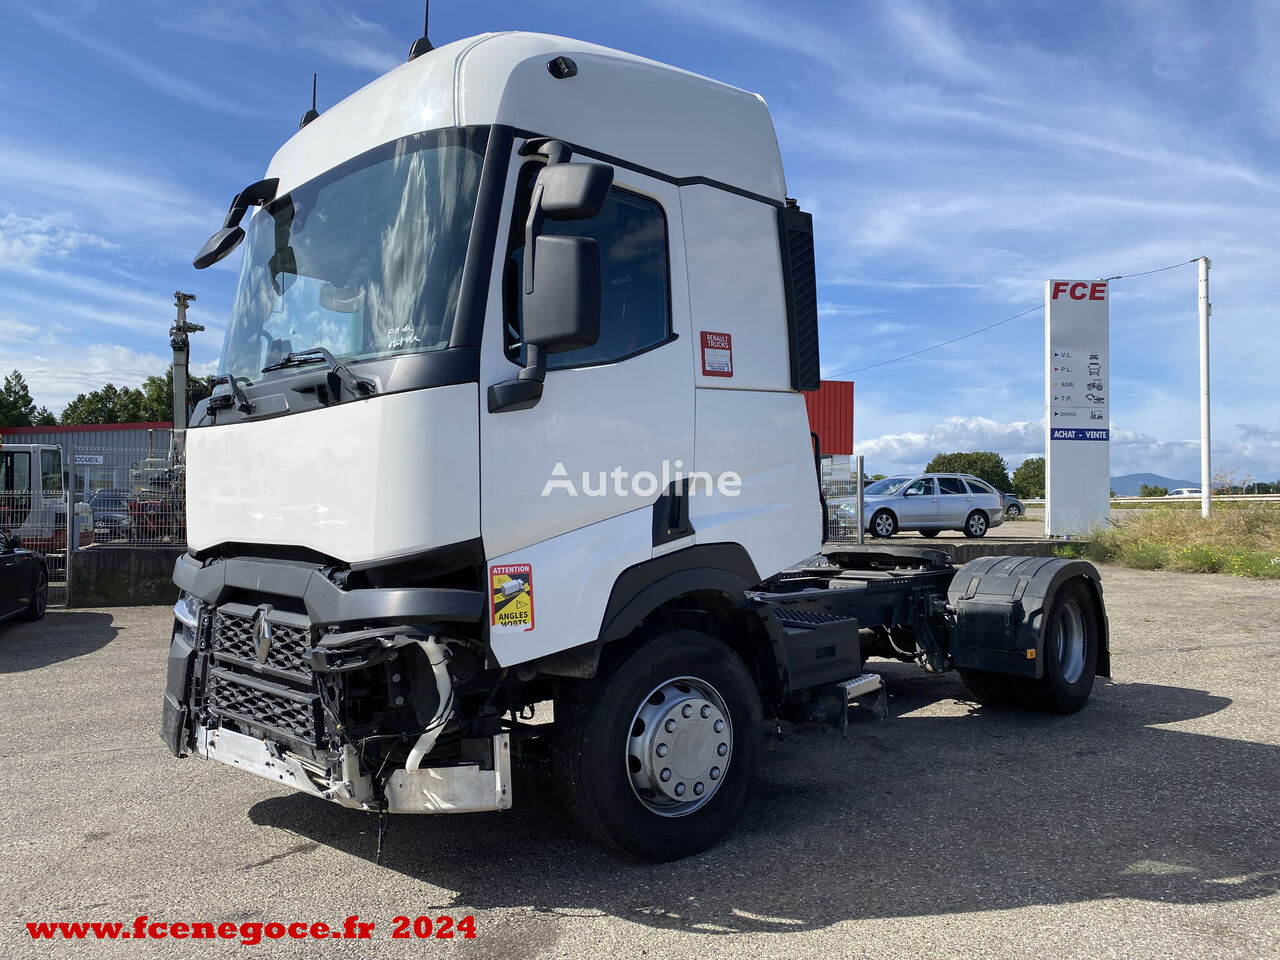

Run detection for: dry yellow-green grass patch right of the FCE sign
[[1056, 503, 1280, 580]]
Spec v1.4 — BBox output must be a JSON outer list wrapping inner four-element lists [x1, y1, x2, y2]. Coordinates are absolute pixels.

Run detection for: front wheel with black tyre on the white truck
[[552, 628, 762, 863]]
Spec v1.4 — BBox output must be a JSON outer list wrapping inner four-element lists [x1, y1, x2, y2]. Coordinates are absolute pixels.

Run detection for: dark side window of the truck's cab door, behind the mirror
[[503, 163, 671, 370]]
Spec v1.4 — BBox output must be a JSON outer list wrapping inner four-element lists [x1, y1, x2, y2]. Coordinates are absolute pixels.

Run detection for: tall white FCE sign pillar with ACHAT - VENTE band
[[1044, 280, 1111, 536]]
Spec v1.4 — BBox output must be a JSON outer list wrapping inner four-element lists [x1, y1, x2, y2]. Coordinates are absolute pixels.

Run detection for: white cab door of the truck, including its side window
[[479, 142, 694, 663]]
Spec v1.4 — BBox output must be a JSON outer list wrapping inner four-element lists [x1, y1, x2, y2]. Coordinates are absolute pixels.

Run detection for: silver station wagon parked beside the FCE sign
[[837, 474, 1005, 538]]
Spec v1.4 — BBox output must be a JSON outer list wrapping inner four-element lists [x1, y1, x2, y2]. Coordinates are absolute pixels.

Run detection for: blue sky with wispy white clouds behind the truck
[[0, 0, 1280, 480]]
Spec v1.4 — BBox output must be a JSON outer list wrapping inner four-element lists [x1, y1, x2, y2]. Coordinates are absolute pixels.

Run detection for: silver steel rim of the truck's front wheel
[[625, 677, 733, 817]]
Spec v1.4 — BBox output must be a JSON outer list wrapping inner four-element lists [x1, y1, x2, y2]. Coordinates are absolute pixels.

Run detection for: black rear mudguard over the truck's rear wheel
[[947, 557, 1111, 680]]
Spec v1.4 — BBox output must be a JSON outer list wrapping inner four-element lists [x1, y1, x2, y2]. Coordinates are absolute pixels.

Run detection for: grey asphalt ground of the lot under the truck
[[0, 567, 1280, 960]]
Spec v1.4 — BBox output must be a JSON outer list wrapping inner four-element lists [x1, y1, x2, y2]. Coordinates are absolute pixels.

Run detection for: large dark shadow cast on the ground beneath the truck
[[250, 664, 1280, 934]]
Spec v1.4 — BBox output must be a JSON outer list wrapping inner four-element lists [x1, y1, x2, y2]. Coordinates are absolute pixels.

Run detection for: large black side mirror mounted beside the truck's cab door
[[489, 163, 613, 413]]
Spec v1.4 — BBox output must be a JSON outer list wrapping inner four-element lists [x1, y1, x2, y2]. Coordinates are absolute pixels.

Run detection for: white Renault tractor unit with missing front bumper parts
[[163, 33, 1108, 860]]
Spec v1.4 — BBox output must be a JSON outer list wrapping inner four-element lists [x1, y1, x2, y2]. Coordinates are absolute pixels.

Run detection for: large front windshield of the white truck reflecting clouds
[[220, 129, 485, 383]]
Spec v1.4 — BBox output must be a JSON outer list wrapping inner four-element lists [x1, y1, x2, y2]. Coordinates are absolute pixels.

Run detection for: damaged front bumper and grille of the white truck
[[160, 557, 512, 813]]
